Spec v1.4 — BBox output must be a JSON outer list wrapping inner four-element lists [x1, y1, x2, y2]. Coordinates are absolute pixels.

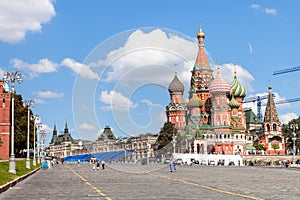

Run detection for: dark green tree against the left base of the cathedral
[[156, 122, 177, 149]]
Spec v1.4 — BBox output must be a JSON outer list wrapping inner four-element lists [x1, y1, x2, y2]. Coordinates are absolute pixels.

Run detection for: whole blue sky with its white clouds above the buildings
[[0, 0, 300, 143]]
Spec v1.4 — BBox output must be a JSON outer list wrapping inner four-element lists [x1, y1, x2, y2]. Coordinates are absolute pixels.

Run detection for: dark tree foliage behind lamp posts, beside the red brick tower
[[14, 94, 34, 154]]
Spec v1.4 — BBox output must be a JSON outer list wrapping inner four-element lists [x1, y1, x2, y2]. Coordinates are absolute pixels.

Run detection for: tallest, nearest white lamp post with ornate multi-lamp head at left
[[3, 71, 22, 174]]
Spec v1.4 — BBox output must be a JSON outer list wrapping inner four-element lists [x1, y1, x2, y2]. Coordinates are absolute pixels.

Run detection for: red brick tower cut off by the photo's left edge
[[0, 80, 11, 159]]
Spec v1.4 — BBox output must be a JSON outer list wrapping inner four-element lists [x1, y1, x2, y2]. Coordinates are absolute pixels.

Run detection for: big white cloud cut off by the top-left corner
[[0, 0, 56, 43]]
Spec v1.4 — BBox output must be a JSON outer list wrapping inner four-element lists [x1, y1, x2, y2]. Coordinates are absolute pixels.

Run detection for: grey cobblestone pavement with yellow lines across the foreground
[[0, 164, 300, 200]]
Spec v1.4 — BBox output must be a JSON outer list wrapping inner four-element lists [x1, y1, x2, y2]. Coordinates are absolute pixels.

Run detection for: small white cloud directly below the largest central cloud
[[100, 90, 138, 111]]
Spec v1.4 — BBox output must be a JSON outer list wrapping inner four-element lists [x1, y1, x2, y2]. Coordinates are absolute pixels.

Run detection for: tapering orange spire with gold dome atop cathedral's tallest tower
[[195, 26, 208, 68]]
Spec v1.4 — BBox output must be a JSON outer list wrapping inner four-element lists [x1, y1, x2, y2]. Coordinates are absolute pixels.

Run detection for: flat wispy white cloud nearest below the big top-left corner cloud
[[11, 58, 59, 78]]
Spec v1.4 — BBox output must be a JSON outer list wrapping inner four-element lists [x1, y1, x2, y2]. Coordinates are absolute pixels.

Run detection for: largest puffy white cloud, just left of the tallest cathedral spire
[[94, 29, 198, 84]]
